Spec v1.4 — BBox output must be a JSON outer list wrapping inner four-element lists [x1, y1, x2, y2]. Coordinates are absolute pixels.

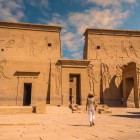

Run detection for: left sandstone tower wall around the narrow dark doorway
[[0, 23, 61, 105]]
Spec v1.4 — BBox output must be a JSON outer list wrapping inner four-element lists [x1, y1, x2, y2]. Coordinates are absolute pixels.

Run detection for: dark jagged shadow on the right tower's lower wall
[[100, 75, 123, 107]]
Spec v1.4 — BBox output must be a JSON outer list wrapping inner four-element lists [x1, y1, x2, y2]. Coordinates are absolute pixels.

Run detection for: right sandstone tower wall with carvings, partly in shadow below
[[84, 29, 140, 105]]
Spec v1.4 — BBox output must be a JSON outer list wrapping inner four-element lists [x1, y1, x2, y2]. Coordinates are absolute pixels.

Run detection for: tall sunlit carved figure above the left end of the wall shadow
[[102, 64, 111, 90]]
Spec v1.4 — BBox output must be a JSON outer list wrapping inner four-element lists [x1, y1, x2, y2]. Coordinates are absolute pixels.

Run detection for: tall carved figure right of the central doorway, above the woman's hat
[[87, 64, 97, 94]]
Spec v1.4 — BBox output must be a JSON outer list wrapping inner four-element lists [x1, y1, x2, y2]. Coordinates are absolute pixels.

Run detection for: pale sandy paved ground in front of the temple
[[0, 106, 140, 140]]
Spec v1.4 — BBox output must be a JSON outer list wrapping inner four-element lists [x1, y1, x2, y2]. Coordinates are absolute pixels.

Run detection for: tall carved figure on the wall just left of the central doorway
[[52, 65, 61, 95]]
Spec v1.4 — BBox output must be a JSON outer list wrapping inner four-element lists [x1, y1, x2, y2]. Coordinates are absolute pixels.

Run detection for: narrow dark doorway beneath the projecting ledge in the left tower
[[23, 83, 32, 106]]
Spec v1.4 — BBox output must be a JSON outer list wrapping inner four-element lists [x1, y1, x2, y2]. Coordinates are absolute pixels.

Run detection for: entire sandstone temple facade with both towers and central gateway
[[0, 22, 140, 107]]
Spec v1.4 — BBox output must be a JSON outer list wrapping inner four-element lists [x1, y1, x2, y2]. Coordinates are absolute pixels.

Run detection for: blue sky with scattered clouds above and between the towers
[[0, 0, 140, 59]]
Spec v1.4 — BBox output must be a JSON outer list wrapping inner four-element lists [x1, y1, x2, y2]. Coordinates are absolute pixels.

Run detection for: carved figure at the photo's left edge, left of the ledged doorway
[[0, 59, 10, 79]]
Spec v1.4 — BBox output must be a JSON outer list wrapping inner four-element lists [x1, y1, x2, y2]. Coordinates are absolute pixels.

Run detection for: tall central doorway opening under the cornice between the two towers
[[69, 74, 81, 105]]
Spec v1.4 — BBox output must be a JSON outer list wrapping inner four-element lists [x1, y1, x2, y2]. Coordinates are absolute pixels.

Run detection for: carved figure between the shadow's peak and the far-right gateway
[[115, 65, 122, 88]]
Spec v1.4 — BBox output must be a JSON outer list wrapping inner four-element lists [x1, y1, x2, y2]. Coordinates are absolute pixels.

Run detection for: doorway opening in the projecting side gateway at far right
[[125, 78, 135, 107]]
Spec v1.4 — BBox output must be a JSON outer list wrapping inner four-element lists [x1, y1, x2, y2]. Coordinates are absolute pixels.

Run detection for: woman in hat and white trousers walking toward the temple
[[86, 92, 97, 126]]
